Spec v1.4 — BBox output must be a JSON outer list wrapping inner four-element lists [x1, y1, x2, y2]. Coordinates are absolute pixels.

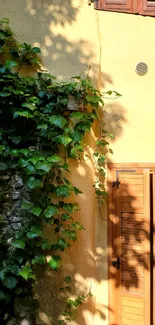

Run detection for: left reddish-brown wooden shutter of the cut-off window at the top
[[95, 0, 137, 13]]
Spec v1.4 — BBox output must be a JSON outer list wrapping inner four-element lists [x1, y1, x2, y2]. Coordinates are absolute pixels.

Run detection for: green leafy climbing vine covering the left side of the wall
[[0, 19, 111, 324]]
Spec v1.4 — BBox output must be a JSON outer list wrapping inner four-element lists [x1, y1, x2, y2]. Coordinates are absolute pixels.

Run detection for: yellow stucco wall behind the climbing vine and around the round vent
[[0, 0, 155, 325]]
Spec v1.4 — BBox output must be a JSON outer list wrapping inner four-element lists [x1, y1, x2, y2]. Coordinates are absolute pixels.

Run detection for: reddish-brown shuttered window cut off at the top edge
[[95, 0, 155, 16]]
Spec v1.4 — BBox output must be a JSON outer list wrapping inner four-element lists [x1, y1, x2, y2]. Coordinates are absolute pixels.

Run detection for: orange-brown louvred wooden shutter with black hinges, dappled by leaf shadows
[[109, 168, 151, 325]]
